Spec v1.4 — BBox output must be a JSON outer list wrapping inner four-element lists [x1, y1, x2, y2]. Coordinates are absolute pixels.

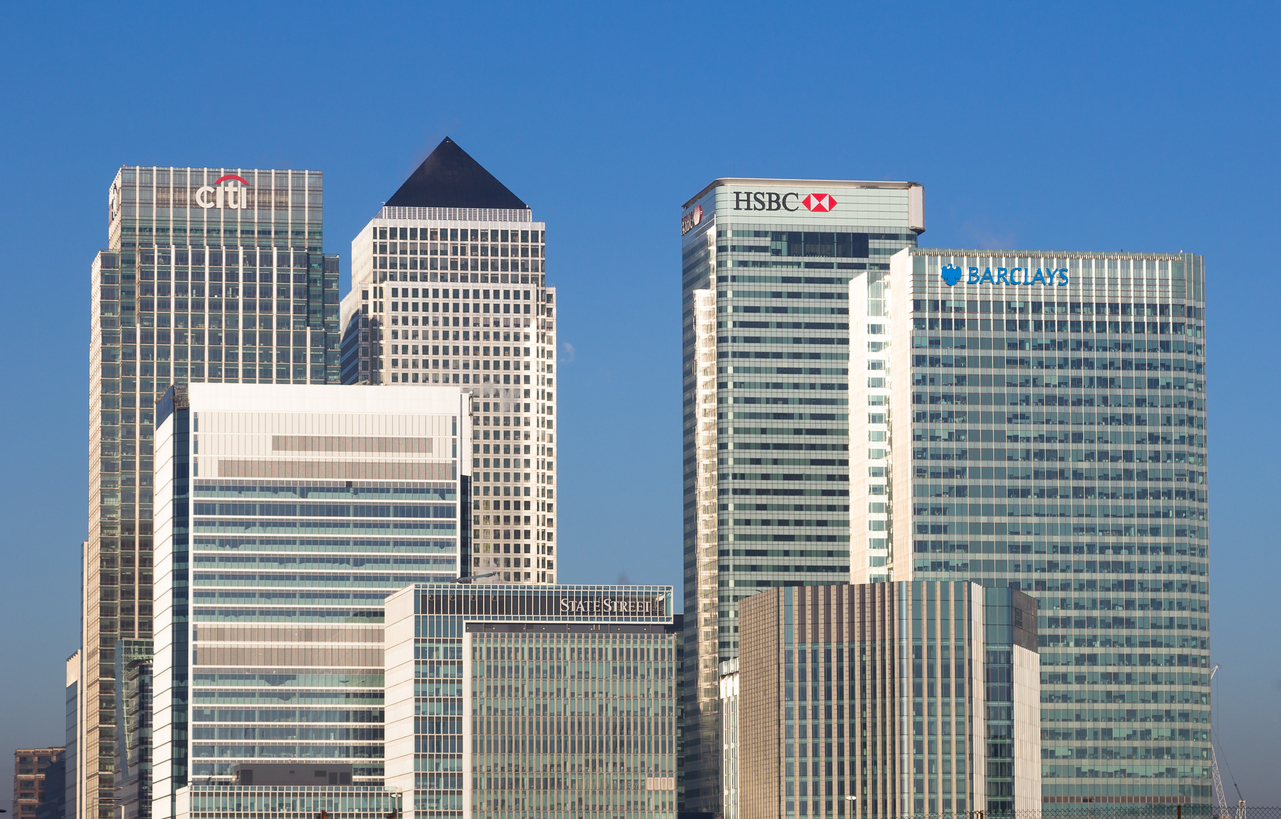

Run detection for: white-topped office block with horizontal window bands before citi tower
[[152, 385, 471, 819]]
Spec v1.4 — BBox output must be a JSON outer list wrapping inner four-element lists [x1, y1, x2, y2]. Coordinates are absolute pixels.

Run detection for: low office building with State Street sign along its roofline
[[386, 584, 680, 819]]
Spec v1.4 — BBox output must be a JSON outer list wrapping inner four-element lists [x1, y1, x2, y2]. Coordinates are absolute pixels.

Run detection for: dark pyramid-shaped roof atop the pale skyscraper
[[387, 137, 529, 210]]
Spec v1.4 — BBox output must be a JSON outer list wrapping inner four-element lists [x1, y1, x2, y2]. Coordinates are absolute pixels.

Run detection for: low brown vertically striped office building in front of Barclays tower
[[730, 581, 1040, 819]]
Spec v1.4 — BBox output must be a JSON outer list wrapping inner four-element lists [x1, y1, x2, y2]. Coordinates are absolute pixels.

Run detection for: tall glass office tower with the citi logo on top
[[87, 165, 338, 819]]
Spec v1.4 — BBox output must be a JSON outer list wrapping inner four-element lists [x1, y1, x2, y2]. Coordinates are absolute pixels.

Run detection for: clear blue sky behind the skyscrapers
[[0, 1, 1281, 805]]
